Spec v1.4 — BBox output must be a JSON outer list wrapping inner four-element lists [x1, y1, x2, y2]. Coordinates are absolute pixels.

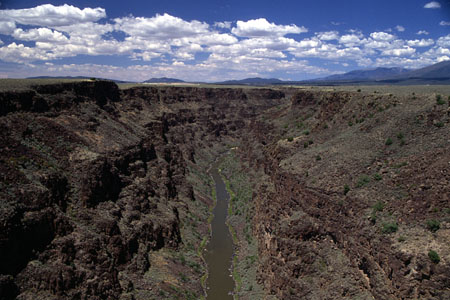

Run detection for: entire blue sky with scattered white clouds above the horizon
[[0, 0, 450, 82]]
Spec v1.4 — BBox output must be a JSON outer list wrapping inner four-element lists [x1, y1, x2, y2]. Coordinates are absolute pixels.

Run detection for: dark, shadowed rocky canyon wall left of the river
[[0, 81, 283, 299]]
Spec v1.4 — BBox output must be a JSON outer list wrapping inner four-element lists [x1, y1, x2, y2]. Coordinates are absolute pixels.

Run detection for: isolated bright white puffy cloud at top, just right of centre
[[231, 18, 308, 37]]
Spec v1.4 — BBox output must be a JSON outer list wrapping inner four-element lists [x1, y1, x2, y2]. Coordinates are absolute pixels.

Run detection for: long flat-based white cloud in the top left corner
[[0, 4, 106, 27]]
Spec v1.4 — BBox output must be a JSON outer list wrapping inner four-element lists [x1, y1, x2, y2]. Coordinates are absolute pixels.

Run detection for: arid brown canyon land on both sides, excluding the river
[[0, 80, 450, 300]]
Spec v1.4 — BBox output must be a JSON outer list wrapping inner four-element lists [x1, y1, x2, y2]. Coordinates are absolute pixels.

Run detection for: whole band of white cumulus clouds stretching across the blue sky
[[0, 5, 450, 81]]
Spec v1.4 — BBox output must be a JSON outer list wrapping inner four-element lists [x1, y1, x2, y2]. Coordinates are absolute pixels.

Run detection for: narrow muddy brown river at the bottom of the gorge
[[205, 162, 234, 300]]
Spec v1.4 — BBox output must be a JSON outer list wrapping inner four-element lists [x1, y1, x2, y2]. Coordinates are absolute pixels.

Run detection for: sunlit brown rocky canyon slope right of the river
[[237, 91, 450, 299]]
